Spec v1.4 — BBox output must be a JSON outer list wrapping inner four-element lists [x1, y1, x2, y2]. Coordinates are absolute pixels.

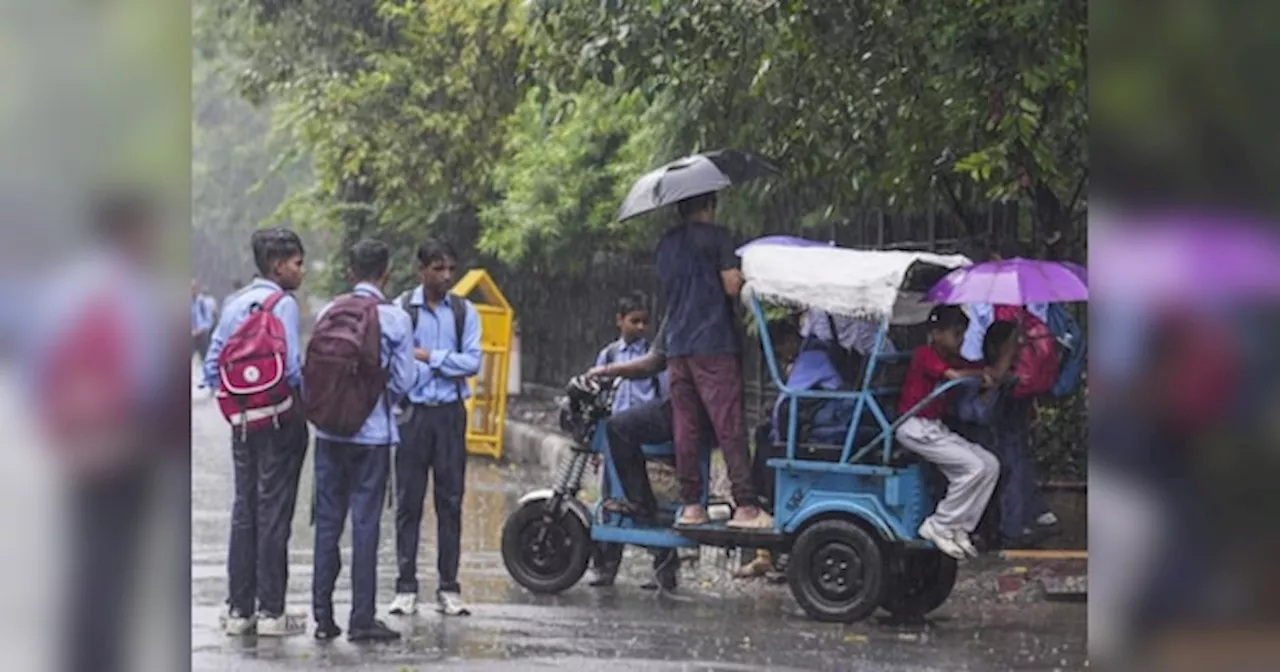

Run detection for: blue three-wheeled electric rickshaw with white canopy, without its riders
[[502, 244, 969, 622]]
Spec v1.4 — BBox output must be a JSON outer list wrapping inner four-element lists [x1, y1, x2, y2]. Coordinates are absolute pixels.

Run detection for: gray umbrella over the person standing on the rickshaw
[[618, 150, 782, 221]]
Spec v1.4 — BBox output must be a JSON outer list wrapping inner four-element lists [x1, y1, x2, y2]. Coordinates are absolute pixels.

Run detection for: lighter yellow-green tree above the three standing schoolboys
[[199, 0, 527, 291]]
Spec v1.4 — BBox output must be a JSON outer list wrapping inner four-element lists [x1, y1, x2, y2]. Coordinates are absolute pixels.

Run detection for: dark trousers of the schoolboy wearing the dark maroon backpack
[[311, 439, 392, 630]]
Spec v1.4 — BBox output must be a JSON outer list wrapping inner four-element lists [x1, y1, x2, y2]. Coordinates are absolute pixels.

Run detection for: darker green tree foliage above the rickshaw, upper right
[[524, 0, 1087, 256]]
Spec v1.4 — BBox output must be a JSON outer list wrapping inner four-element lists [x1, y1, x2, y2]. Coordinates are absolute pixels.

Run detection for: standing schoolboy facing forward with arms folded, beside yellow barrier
[[390, 238, 480, 616]]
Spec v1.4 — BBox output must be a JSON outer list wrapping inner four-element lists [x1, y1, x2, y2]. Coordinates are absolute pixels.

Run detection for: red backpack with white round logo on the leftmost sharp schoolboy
[[218, 292, 293, 438]]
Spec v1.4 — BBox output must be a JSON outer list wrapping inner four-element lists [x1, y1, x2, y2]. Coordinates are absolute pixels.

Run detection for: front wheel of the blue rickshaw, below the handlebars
[[502, 500, 591, 594]]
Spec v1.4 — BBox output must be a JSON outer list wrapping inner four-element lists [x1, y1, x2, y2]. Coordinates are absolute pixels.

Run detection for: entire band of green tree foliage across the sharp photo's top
[[201, 0, 1088, 273]]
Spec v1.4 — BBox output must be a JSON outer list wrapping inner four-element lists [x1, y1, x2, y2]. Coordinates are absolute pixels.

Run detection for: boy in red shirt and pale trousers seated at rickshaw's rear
[[895, 306, 1000, 558]]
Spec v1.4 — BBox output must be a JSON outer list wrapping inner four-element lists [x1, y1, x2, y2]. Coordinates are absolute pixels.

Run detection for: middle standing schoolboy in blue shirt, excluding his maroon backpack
[[308, 241, 417, 641]]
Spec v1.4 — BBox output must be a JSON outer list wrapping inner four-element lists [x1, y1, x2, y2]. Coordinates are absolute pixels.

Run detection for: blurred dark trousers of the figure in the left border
[[63, 467, 154, 672]]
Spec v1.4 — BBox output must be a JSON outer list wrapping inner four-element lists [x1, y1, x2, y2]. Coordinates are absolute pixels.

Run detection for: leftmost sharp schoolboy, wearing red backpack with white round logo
[[204, 227, 307, 636]]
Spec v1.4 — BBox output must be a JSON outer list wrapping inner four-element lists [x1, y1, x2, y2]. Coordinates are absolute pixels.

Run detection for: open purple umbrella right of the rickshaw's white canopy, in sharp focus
[[925, 259, 1089, 306]]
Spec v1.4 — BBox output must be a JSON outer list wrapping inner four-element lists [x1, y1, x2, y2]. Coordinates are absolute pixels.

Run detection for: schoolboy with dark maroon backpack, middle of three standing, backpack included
[[303, 241, 417, 641]]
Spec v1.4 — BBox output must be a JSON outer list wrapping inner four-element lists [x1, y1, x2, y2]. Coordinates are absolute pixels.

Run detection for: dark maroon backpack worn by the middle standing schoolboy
[[302, 293, 388, 436]]
